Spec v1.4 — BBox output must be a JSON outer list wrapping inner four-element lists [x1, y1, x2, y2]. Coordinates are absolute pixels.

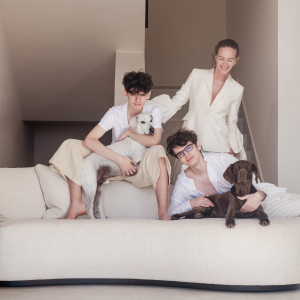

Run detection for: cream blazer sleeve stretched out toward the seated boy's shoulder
[[148, 69, 195, 123]]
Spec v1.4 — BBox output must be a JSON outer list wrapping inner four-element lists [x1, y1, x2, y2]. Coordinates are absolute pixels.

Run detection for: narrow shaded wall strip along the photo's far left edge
[[0, 1, 33, 167]]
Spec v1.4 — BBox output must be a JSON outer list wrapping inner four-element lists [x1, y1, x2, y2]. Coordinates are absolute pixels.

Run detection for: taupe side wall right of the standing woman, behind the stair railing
[[226, 0, 278, 184]]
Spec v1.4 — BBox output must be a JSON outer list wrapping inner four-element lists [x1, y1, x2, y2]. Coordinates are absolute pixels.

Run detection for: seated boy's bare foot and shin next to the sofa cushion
[[66, 178, 86, 219]]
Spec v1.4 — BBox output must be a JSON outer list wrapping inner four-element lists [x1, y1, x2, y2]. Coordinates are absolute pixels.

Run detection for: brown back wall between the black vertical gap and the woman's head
[[145, 0, 226, 86]]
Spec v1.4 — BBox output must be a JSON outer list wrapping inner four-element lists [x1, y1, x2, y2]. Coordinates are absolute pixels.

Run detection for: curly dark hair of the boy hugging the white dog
[[122, 70, 153, 94]]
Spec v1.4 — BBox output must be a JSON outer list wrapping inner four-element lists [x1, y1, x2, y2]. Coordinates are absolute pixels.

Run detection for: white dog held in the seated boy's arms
[[81, 113, 154, 219]]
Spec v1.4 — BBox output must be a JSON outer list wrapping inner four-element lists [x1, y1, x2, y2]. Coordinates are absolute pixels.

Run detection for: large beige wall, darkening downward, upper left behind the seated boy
[[2, 0, 145, 121]]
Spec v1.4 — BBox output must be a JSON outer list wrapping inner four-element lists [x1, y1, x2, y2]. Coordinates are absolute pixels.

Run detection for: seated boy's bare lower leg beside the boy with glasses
[[156, 157, 171, 221]]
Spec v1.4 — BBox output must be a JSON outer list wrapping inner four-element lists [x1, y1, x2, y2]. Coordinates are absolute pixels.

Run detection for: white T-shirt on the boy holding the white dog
[[98, 102, 162, 144]]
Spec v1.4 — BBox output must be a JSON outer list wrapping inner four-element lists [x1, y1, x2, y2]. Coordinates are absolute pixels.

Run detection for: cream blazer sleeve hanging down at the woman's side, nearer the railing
[[227, 87, 245, 154]]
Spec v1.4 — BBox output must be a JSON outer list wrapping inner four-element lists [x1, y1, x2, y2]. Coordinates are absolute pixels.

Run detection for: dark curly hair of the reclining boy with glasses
[[167, 128, 198, 157]]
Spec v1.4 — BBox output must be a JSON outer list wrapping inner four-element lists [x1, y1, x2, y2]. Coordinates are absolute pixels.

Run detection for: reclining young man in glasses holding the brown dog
[[167, 129, 292, 217]]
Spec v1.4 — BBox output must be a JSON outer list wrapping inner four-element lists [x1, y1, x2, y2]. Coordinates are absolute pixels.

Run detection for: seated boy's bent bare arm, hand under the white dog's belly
[[83, 125, 136, 176]]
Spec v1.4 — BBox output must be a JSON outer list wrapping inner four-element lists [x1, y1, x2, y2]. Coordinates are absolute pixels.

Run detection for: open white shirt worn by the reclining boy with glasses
[[168, 153, 286, 216]]
